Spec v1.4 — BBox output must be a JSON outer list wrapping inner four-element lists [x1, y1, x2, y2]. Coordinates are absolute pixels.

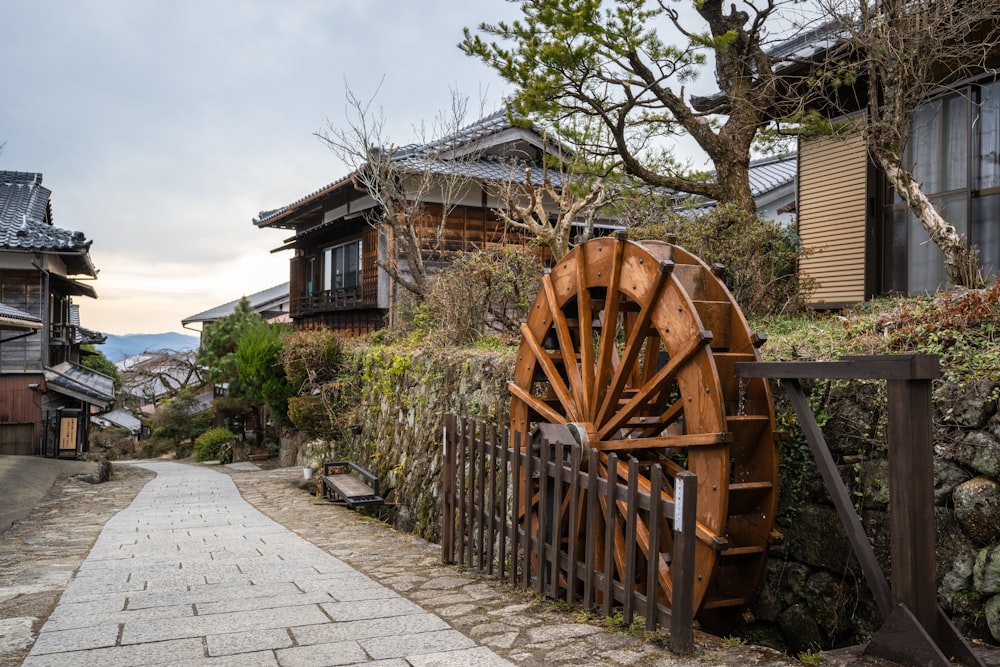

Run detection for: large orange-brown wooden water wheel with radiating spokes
[[510, 234, 777, 632]]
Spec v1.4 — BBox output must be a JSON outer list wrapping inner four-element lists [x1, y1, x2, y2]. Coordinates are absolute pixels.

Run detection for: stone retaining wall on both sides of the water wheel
[[296, 347, 1000, 654]]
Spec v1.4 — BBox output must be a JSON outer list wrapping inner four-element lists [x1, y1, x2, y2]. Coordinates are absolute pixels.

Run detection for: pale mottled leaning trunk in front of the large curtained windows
[[877, 160, 985, 288]]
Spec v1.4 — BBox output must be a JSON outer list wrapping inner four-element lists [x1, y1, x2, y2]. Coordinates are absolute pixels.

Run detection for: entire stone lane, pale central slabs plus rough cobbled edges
[[0, 462, 936, 667]]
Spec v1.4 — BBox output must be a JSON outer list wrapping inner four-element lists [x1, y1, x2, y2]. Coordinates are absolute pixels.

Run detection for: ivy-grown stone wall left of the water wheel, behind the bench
[[298, 346, 514, 542]]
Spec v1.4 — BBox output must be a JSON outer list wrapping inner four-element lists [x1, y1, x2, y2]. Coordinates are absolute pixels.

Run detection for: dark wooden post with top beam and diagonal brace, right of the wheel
[[734, 354, 983, 667]]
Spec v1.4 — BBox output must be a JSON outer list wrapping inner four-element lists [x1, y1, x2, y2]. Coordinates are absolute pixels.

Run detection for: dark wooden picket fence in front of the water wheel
[[441, 413, 697, 653]]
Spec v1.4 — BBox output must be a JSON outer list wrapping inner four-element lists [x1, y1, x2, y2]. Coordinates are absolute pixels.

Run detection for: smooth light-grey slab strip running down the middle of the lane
[[23, 462, 510, 667]]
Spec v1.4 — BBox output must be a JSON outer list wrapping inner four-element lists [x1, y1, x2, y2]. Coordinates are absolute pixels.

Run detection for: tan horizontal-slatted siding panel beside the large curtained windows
[[798, 137, 868, 307]]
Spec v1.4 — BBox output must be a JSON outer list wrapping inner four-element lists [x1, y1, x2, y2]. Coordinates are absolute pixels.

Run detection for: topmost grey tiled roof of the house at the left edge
[[0, 171, 90, 260]]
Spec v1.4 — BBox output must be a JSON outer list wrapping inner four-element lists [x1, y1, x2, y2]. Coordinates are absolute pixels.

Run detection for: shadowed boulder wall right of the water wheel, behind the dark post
[[752, 381, 1000, 654]]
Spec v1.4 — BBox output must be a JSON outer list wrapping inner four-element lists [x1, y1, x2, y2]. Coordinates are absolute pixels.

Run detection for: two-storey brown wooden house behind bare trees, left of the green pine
[[254, 112, 613, 335]]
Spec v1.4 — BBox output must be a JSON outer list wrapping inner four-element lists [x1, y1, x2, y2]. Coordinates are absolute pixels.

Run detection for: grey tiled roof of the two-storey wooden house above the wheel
[[254, 111, 557, 226]]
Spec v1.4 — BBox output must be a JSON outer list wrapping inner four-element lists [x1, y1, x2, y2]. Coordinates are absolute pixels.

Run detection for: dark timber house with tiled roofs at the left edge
[[0, 171, 114, 456]]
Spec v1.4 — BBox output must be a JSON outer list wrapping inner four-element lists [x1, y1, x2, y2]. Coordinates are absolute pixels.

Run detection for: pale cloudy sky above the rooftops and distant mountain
[[0, 0, 516, 334]]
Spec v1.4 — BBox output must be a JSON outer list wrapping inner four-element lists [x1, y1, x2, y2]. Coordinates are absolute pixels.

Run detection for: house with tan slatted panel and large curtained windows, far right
[[775, 27, 1000, 309]]
